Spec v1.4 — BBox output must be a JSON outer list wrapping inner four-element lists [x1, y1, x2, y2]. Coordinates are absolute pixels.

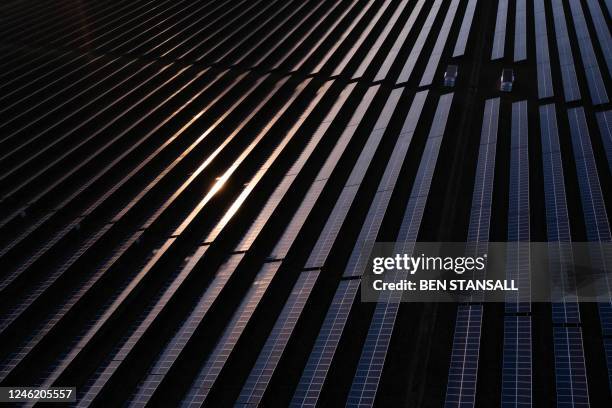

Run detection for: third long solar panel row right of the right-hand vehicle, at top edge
[[569, 0, 609, 105]]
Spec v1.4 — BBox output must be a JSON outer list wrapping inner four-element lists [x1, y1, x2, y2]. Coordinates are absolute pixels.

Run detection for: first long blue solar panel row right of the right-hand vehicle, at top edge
[[533, 0, 553, 99]]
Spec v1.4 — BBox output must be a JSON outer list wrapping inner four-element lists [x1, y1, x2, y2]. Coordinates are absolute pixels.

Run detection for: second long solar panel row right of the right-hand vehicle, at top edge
[[552, 0, 581, 102]]
